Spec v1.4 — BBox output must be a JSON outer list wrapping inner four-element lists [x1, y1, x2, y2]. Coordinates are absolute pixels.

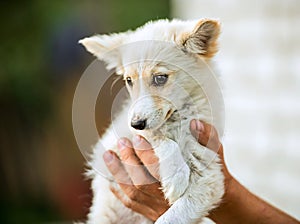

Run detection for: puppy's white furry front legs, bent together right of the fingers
[[155, 140, 224, 224]]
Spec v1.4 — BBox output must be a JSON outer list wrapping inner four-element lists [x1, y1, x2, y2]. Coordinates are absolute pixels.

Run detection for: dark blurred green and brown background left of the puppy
[[0, 0, 170, 223]]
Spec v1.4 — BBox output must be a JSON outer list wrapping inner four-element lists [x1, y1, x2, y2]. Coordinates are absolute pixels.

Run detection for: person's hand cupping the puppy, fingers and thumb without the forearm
[[104, 120, 227, 221]]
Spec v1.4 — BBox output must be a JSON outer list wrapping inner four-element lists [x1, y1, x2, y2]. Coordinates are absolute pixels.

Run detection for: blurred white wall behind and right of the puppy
[[172, 0, 300, 219]]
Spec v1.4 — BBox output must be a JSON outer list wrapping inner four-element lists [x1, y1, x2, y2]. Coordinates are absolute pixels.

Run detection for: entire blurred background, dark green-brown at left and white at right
[[0, 0, 300, 223]]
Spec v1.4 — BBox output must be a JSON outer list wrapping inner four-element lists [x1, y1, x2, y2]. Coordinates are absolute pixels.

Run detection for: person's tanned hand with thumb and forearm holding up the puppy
[[104, 120, 300, 224]]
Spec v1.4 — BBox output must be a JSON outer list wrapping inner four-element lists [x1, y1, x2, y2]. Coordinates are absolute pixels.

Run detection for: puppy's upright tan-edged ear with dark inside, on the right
[[182, 19, 220, 58]]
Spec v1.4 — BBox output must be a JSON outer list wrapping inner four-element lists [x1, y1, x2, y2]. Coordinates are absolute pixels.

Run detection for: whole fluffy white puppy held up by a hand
[[80, 19, 224, 224]]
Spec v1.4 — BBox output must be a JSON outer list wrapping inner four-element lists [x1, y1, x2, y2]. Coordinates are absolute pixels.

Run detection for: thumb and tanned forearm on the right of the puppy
[[191, 120, 300, 224]]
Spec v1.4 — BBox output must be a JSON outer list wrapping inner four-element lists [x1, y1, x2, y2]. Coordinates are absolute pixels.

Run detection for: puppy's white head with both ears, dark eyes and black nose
[[79, 19, 220, 130]]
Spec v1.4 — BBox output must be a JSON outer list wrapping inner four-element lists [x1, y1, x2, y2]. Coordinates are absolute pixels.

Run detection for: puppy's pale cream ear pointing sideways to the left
[[79, 33, 126, 69]]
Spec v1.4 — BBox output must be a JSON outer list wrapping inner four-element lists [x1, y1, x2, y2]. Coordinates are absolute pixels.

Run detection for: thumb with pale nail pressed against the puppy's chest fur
[[190, 119, 222, 154]]
